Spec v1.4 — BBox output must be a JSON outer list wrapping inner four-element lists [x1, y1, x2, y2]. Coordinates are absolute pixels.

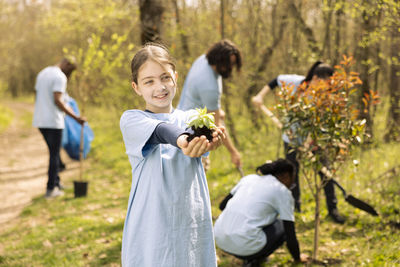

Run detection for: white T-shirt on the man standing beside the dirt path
[[33, 66, 67, 129]]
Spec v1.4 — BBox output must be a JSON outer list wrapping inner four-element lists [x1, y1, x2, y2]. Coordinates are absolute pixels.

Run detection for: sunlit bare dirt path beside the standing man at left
[[0, 101, 79, 230]]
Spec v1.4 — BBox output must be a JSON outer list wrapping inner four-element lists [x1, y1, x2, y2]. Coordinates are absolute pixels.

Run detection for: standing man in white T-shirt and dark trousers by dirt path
[[32, 58, 86, 198]]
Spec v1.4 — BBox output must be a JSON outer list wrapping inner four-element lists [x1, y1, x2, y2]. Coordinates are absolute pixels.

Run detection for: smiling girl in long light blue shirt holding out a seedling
[[120, 44, 225, 267]]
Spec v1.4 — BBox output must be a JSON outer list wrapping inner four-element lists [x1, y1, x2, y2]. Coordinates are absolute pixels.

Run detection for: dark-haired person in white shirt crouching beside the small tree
[[214, 159, 307, 267]]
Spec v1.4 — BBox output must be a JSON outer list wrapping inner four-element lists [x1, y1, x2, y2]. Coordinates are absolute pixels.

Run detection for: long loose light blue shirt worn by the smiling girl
[[120, 110, 217, 267]]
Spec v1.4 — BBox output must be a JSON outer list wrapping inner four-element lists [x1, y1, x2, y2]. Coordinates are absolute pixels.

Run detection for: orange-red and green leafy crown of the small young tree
[[276, 56, 378, 177]]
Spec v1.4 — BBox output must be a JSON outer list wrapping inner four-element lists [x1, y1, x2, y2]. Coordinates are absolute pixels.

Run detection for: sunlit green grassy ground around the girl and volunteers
[[0, 99, 400, 267]]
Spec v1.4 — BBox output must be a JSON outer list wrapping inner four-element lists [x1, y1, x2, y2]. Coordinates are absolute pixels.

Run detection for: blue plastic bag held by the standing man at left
[[62, 97, 94, 160]]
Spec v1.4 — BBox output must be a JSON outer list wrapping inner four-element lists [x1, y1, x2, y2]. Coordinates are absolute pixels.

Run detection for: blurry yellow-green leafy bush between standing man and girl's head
[[64, 33, 134, 113]]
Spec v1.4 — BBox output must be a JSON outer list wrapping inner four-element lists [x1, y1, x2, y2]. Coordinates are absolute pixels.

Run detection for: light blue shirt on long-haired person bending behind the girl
[[178, 55, 222, 110]]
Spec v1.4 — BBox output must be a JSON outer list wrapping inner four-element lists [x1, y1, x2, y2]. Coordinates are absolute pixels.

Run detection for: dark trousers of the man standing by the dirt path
[[39, 128, 62, 190]]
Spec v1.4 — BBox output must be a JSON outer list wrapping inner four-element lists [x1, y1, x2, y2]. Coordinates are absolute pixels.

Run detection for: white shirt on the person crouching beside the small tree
[[214, 174, 294, 255]]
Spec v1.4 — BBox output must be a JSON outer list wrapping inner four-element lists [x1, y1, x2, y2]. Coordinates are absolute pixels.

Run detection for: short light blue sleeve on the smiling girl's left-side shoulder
[[120, 110, 162, 158]]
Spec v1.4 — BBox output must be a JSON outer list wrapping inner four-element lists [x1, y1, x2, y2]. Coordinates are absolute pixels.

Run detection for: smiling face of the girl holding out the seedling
[[132, 60, 177, 113]]
